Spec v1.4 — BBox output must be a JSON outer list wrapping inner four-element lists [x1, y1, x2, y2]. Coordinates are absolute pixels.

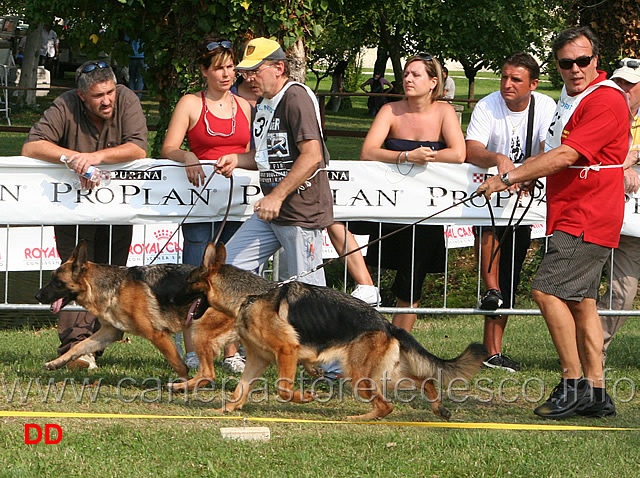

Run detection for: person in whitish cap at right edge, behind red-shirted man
[[598, 58, 640, 358]]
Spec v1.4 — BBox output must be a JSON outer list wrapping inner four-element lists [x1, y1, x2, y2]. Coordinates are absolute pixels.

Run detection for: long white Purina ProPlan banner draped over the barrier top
[[0, 157, 545, 225]]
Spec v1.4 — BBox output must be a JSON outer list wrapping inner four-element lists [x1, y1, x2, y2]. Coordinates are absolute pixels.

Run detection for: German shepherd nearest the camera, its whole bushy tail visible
[[189, 244, 487, 419]]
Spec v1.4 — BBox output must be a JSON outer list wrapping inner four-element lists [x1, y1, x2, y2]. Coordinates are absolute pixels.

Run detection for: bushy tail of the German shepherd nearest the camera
[[391, 327, 487, 387]]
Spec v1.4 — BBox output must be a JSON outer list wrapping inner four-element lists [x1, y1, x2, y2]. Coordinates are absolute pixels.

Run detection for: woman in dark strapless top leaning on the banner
[[360, 53, 465, 332]]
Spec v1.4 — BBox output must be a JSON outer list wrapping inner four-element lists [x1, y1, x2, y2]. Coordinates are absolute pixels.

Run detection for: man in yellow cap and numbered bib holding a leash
[[217, 38, 333, 285]]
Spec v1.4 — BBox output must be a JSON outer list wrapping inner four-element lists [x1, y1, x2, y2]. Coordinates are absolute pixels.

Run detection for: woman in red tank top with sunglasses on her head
[[161, 37, 251, 373]]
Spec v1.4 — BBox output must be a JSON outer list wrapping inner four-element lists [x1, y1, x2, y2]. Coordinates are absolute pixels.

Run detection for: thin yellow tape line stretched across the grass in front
[[0, 411, 640, 432]]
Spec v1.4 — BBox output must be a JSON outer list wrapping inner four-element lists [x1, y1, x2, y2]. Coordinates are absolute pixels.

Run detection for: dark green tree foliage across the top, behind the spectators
[[6, 0, 640, 122]]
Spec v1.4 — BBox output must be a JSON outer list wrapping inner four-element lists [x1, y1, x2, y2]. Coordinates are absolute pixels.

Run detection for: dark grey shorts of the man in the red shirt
[[531, 231, 611, 302]]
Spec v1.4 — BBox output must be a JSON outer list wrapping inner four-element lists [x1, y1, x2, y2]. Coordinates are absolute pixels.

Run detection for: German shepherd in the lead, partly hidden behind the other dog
[[35, 241, 237, 390]]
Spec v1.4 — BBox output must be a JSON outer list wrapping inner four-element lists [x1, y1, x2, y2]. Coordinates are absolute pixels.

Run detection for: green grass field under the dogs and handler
[[0, 317, 640, 477]]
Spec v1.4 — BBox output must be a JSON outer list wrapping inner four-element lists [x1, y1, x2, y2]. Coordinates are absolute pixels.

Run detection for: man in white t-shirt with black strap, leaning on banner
[[466, 52, 556, 372]]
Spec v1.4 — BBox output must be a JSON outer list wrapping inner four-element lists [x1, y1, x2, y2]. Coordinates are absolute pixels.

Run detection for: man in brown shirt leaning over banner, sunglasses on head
[[22, 61, 147, 368]]
